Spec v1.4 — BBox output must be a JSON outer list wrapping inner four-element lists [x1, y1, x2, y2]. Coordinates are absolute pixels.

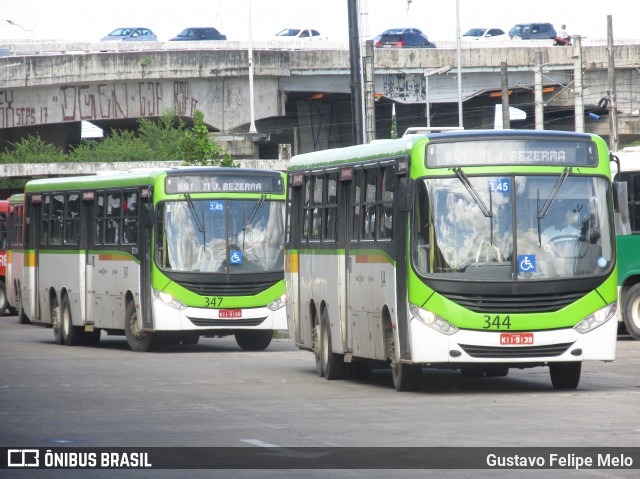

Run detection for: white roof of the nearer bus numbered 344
[[289, 130, 596, 171]]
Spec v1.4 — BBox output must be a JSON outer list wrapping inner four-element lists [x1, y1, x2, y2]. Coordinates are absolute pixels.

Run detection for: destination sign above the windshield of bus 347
[[165, 175, 284, 194]]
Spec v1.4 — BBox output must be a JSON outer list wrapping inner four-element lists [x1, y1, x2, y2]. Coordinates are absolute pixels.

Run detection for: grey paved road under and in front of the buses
[[0, 316, 640, 478]]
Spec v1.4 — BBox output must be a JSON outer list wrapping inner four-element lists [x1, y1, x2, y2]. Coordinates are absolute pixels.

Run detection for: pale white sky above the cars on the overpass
[[0, 0, 640, 43]]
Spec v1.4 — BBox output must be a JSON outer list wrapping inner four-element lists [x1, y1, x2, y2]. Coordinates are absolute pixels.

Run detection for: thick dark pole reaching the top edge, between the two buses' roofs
[[347, 0, 363, 145]]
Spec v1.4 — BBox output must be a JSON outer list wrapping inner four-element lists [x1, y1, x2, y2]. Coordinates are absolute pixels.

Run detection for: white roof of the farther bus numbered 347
[[25, 166, 281, 192]]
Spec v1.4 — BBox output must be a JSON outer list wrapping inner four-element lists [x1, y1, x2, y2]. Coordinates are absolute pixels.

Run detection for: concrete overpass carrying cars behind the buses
[[0, 41, 640, 158]]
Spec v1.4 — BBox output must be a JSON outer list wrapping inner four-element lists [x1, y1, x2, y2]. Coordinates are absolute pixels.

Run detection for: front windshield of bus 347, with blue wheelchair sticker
[[156, 198, 284, 274]]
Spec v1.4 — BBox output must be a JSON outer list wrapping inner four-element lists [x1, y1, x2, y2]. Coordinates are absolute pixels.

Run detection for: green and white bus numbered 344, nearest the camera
[[285, 130, 618, 390]]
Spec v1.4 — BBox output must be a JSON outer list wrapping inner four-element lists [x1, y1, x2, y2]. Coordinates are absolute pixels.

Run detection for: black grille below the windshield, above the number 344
[[444, 291, 588, 313]]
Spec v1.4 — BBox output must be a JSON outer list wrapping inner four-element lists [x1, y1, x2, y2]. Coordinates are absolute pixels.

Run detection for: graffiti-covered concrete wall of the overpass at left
[[0, 81, 198, 128]]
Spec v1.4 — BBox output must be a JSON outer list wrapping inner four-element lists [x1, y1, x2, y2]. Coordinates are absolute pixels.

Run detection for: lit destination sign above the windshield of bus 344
[[426, 140, 598, 168]]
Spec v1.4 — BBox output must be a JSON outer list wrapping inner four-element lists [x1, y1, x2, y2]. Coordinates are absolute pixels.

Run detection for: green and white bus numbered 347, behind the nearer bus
[[21, 168, 287, 351]]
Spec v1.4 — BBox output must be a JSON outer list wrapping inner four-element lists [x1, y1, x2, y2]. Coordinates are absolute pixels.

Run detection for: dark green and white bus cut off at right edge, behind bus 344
[[614, 151, 640, 340]]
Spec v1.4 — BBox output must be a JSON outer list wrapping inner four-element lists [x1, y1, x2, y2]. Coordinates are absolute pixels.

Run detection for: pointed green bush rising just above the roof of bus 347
[[178, 110, 235, 166]]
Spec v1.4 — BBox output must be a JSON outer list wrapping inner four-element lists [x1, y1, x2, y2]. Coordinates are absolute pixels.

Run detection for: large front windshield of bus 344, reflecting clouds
[[412, 175, 614, 281]]
